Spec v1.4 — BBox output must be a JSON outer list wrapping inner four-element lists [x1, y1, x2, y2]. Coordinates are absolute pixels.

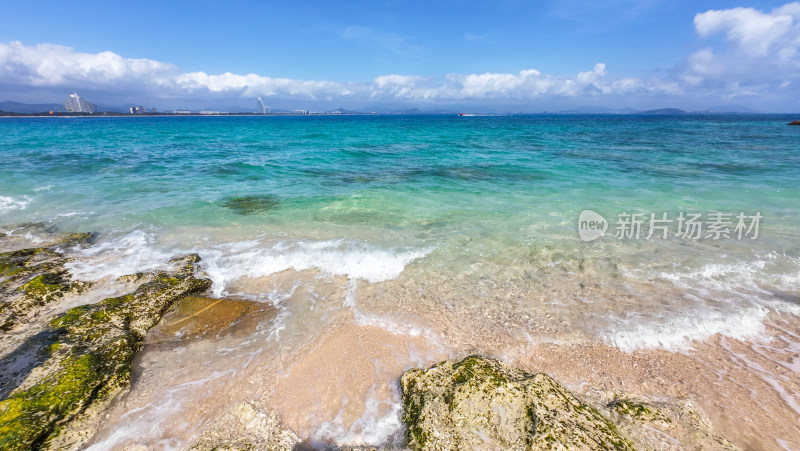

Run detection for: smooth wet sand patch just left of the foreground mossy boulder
[[265, 315, 448, 444]]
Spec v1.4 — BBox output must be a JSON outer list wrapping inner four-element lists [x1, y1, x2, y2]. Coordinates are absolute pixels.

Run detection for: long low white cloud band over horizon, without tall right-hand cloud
[[0, 42, 674, 106]]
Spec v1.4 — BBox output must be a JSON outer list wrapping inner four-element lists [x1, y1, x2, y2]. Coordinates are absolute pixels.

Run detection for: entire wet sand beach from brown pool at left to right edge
[[89, 286, 800, 450]]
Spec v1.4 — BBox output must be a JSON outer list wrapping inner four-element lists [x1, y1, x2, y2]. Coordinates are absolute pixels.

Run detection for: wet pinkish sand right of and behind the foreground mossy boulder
[[513, 322, 800, 450]]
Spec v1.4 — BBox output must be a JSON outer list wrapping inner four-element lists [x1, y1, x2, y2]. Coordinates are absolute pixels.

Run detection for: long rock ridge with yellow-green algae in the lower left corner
[[0, 255, 211, 450]]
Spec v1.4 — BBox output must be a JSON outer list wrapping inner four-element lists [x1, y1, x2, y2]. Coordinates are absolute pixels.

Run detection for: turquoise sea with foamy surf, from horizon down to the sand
[[0, 115, 800, 443]]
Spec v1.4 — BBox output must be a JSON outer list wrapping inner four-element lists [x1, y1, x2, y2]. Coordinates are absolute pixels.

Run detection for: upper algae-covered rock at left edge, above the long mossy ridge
[[0, 233, 92, 332]]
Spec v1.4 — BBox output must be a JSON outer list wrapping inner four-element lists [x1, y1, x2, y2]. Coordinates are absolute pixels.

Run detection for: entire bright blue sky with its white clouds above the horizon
[[0, 0, 800, 111]]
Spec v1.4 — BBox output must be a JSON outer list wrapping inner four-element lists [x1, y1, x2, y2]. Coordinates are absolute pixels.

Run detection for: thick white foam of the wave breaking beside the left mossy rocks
[[62, 230, 431, 296]]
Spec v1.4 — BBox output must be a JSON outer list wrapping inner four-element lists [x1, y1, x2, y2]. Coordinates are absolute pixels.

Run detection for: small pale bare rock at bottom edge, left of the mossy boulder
[[191, 402, 300, 451]]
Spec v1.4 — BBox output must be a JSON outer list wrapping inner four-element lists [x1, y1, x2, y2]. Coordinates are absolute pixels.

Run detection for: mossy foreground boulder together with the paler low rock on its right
[[401, 356, 738, 450]]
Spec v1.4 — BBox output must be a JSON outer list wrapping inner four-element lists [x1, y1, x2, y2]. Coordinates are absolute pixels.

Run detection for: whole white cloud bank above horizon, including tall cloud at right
[[0, 2, 800, 111]]
